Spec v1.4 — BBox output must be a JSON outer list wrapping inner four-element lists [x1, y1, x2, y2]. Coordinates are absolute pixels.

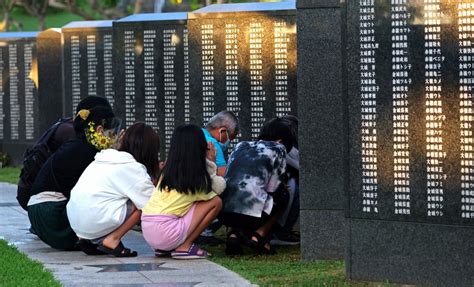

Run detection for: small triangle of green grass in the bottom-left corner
[[0, 240, 61, 286]]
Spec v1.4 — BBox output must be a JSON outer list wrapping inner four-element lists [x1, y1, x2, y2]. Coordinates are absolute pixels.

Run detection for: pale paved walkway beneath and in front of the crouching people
[[0, 183, 254, 286]]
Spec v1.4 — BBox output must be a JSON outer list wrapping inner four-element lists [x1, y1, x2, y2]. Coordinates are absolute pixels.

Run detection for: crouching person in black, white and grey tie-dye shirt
[[219, 118, 294, 255]]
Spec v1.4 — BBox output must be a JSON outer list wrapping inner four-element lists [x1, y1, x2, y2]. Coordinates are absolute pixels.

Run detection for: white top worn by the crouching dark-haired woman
[[67, 149, 154, 239]]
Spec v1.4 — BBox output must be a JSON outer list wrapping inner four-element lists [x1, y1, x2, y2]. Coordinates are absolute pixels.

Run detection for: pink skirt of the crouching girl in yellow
[[142, 204, 196, 251]]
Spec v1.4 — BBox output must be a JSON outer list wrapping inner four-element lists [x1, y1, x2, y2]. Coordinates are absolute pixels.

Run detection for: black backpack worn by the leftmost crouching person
[[20, 118, 71, 189]]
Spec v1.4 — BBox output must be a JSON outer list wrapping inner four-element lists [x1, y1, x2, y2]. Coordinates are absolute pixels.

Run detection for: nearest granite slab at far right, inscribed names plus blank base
[[346, 0, 474, 286]]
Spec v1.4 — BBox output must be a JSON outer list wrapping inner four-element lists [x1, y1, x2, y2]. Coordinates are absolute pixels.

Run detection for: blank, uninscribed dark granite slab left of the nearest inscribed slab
[[297, 0, 348, 259]]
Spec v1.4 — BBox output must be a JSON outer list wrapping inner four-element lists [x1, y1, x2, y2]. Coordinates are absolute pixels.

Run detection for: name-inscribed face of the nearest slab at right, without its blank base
[[347, 0, 474, 225]]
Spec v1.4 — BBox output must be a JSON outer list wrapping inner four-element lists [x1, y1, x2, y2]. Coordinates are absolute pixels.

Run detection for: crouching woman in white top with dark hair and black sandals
[[67, 123, 160, 257]]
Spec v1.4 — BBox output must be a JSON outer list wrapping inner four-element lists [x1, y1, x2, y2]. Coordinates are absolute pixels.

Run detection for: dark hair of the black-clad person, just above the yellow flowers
[[74, 106, 114, 137]]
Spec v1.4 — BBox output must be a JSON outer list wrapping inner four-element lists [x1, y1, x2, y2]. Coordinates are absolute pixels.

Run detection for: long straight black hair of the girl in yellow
[[160, 124, 211, 194]]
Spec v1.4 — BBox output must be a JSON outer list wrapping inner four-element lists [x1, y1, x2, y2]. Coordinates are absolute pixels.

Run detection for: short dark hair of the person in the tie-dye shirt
[[258, 118, 295, 152]]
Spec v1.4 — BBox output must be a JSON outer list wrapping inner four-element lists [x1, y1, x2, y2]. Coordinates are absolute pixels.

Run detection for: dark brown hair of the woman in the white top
[[119, 122, 160, 178]]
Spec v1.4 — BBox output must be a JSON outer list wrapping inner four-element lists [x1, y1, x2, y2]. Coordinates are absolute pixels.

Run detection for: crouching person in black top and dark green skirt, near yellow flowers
[[28, 106, 120, 250]]
